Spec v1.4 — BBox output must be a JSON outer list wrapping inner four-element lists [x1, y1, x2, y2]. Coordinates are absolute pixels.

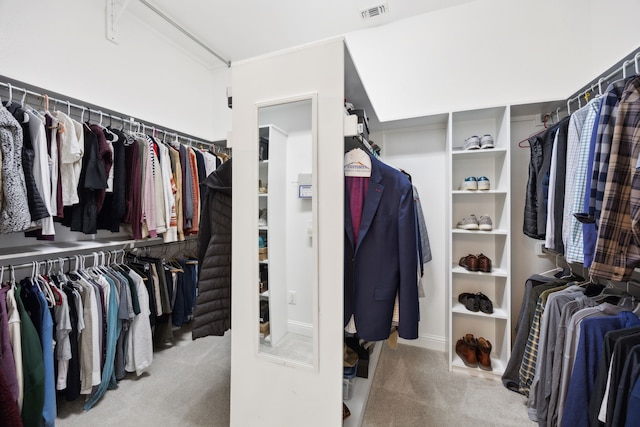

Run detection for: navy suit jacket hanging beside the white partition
[[344, 157, 419, 341]]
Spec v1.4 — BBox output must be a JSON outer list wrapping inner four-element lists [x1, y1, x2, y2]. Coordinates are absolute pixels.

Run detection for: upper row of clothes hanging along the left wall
[[0, 98, 228, 242]]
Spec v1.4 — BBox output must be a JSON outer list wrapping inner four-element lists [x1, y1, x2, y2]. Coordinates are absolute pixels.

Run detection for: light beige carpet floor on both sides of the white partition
[[56, 328, 534, 427]]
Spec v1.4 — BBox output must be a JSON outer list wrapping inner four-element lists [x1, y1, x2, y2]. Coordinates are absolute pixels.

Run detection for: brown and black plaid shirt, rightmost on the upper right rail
[[591, 77, 640, 281]]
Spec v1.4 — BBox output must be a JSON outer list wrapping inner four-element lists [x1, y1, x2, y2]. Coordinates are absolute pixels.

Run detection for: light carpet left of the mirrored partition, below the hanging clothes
[[56, 327, 231, 427]]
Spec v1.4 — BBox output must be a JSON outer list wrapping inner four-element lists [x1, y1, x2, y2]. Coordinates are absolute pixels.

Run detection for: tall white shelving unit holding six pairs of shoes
[[447, 106, 511, 379]]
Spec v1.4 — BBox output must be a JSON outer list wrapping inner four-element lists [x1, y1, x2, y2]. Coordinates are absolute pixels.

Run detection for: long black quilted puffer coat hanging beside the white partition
[[192, 160, 231, 339]]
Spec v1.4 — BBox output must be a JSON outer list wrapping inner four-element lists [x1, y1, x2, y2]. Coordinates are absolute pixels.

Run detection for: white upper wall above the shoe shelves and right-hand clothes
[[346, 0, 640, 121]]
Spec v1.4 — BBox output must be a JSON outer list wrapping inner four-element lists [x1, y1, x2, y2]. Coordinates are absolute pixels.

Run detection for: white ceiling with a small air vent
[[126, 0, 471, 67]]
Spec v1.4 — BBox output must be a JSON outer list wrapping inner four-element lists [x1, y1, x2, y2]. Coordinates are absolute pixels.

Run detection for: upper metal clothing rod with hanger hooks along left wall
[[0, 76, 225, 149]]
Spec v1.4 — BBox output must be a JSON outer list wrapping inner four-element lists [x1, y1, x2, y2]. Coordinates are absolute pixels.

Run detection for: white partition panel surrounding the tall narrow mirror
[[231, 39, 344, 427]]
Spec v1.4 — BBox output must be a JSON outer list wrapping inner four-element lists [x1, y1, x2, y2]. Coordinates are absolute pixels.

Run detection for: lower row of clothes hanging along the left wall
[[0, 247, 197, 426]]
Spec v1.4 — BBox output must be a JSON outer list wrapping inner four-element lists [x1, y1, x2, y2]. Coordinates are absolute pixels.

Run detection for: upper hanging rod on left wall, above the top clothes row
[[0, 76, 226, 150]]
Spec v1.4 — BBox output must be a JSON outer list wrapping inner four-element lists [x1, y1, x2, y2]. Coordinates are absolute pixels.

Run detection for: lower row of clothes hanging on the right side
[[502, 266, 640, 427]]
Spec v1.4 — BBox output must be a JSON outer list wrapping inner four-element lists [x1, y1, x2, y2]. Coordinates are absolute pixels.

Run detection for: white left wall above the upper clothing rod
[[0, 0, 231, 140]]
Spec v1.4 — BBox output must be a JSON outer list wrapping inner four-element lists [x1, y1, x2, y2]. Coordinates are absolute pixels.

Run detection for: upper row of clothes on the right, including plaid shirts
[[524, 76, 640, 281]]
